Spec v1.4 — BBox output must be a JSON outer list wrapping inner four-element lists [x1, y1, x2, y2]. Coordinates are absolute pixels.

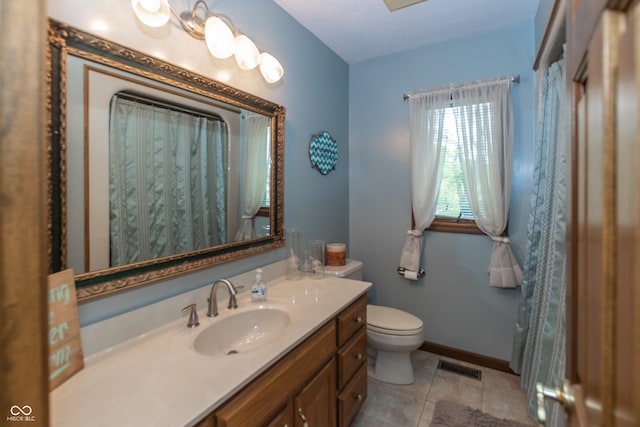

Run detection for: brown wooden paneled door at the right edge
[[567, 1, 640, 426]]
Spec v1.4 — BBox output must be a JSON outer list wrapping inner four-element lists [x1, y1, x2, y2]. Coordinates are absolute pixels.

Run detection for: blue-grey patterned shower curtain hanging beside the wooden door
[[510, 59, 569, 426]]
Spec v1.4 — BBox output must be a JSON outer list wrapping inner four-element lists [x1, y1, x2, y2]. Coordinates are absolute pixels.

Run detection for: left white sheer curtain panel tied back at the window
[[400, 91, 450, 272]]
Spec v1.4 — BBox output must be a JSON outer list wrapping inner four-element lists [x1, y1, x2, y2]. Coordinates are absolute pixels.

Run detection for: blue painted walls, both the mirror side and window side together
[[48, 0, 534, 360]]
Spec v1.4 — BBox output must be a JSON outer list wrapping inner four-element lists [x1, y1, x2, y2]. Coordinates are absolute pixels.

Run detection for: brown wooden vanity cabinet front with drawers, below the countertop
[[205, 296, 367, 427]]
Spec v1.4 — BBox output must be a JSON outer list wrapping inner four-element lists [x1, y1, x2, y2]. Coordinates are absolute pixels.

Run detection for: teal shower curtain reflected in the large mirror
[[109, 93, 228, 266]]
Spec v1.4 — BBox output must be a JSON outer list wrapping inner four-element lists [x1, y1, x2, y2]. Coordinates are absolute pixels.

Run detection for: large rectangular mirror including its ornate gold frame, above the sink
[[48, 20, 285, 301]]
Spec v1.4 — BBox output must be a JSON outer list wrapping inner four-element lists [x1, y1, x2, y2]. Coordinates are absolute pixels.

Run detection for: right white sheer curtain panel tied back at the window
[[454, 79, 522, 288]]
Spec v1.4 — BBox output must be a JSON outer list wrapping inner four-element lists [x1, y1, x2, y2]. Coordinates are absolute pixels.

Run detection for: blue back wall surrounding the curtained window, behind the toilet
[[349, 23, 535, 360]]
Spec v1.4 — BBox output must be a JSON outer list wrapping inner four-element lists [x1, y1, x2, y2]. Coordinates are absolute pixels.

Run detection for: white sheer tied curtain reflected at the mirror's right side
[[235, 114, 270, 241]]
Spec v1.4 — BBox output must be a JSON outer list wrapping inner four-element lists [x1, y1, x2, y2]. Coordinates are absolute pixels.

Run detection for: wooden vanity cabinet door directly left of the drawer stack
[[294, 359, 336, 427]]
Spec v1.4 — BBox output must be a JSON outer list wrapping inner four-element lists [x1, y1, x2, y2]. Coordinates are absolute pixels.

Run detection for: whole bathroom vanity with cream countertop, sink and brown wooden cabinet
[[51, 277, 371, 427]]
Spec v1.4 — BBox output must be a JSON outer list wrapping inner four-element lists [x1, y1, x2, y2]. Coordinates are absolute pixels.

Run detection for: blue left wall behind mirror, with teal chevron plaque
[[48, 0, 349, 326]]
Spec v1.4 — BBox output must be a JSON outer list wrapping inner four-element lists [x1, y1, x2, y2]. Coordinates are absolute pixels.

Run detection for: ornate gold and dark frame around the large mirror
[[47, 20, 285, 301]]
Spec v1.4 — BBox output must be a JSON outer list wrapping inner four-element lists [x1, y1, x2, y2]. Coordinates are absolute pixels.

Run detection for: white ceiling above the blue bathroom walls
[[273, 0, 540, 64]]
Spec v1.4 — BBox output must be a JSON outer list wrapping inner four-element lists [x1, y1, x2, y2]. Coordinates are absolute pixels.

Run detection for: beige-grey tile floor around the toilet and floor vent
[[353, 351, 537, 427]]
